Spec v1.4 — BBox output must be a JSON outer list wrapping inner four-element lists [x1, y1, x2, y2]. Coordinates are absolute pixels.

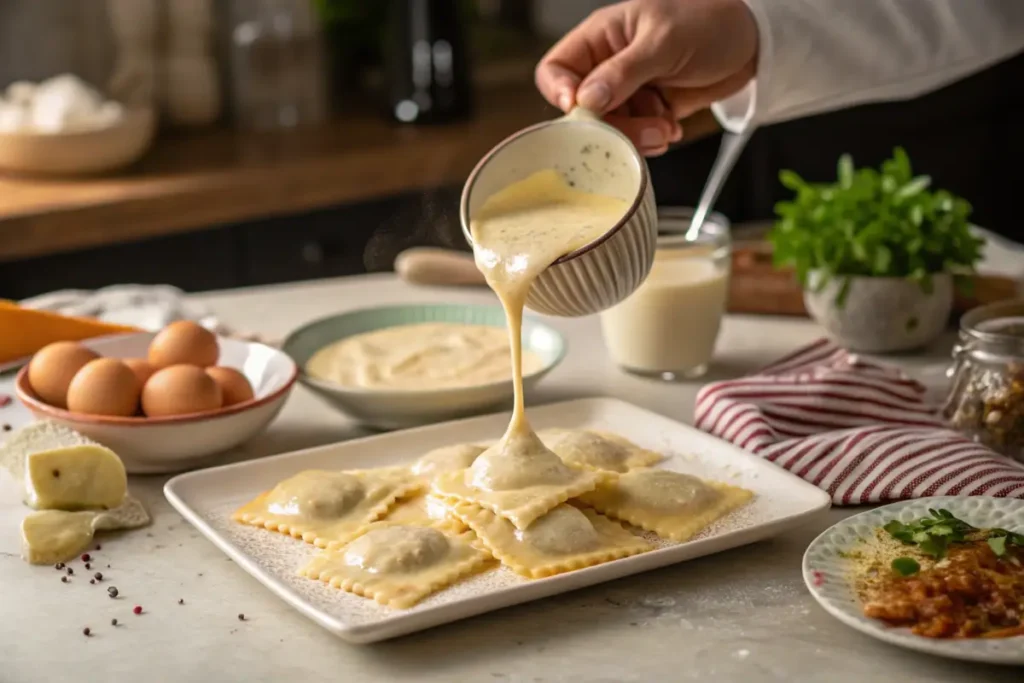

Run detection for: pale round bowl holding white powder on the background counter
[[0, 109, 156, 175]]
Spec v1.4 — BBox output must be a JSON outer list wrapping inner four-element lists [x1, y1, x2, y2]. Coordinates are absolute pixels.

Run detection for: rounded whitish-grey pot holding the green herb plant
[[804, 273, 953, 353]]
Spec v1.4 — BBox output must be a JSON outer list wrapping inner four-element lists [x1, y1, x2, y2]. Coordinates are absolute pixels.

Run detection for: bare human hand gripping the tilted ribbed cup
[[536, 0, 758, 157]]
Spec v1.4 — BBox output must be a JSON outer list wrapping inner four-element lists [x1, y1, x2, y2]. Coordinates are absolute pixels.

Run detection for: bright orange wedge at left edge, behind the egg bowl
[[0, 299, 139, 364]]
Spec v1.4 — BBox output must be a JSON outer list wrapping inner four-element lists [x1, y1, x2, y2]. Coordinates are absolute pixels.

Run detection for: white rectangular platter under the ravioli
[[164, 398, 829, 643]]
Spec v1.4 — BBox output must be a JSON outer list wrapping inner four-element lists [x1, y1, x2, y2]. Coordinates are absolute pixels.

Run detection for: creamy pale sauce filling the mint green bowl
[[306, 323, 544, 390]]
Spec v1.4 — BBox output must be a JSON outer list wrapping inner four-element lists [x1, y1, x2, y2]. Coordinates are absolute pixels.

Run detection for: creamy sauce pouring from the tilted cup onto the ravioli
[[469, 169, 629, 462]]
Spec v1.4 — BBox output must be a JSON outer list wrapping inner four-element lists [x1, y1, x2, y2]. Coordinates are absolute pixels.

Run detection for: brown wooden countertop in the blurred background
[[0, 88, 717, 262]]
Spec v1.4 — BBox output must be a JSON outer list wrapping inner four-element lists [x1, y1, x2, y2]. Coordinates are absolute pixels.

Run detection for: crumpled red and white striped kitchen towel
[[695, 339, 1024, 505]]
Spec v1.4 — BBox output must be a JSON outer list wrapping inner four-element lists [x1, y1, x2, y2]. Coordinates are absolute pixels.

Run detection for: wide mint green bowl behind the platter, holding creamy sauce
[[282, 304, 566, 429]]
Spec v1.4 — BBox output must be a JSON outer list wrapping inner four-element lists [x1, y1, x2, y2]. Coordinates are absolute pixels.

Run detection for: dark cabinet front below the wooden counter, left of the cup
[[0, 188, 466, 299]]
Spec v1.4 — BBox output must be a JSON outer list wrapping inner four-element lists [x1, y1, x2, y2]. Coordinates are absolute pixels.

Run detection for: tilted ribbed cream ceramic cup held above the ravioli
[[460, 109, 657, 316]]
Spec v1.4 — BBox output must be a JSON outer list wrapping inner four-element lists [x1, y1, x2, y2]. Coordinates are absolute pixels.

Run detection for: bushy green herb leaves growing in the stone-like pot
[[769, 147, 984, 305]]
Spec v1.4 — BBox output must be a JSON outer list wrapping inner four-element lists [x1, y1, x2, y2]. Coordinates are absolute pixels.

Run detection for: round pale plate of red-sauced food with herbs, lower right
[[804, 496, 1024, 665]]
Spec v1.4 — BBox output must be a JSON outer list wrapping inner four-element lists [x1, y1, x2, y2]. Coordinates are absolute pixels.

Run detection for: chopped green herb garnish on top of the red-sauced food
[[882, 510, 1024, 561]]
